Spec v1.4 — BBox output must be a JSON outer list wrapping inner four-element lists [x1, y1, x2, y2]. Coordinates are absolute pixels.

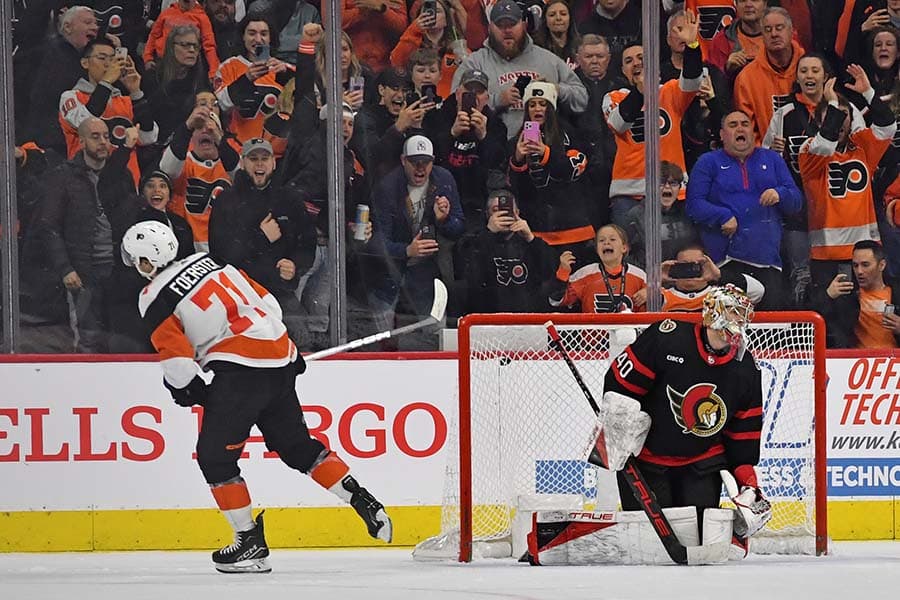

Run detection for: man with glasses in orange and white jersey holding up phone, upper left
[[59, 38, 159, 187]]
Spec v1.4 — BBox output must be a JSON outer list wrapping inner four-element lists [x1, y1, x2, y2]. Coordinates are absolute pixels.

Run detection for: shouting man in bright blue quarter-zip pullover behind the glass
[[686, 111, 802, 310]]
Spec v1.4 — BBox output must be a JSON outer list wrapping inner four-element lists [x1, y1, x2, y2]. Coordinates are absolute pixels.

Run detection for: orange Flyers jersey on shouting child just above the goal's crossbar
[[550, 263, 647, 313]]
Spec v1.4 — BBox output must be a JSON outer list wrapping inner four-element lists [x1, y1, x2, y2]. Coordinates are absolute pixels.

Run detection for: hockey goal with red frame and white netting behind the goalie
[[414, 312, 827, 561]]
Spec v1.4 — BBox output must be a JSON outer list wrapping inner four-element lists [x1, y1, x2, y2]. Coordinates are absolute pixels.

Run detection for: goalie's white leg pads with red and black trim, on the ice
[[528, 506, 700, 565]]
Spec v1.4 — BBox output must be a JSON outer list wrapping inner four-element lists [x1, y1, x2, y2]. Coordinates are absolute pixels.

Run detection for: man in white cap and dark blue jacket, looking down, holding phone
[[371, 135, 465, 350]]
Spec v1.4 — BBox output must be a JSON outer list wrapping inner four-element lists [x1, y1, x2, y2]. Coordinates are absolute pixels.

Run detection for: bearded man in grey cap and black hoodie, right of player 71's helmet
[[209, 138, 316, 345]]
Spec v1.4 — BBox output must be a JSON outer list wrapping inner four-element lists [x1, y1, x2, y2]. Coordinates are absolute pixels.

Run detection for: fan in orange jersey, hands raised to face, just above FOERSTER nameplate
[[159, 92, 240, 250]]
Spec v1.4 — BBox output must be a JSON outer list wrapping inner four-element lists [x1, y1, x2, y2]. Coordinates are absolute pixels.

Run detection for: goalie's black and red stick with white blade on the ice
[[544, 321, 728, 565]]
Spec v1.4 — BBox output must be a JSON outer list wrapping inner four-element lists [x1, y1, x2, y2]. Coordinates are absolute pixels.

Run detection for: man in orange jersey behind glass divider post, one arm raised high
[[603, 12, 703, 227]]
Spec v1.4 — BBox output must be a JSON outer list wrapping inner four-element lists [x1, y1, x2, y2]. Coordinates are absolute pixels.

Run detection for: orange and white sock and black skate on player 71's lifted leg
[[309, 451, 393, 543]]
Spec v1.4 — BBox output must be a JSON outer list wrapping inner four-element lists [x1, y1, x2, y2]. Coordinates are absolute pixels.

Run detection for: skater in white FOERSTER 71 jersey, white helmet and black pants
[[122, 221, 392, 573]]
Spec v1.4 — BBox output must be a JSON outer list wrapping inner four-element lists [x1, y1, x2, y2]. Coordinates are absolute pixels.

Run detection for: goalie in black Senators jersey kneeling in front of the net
[[604, 285, 772, 553]]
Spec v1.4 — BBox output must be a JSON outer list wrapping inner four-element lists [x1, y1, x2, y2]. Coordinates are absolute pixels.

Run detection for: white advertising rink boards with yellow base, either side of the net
[[0, 353, 900, 551]]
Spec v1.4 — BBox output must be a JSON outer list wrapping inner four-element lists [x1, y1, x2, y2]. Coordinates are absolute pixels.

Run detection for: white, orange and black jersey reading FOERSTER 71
[[138, 252, 297, 388]]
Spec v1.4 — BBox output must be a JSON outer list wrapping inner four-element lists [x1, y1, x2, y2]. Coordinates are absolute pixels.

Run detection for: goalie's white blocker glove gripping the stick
[[585, 392, 650, 471]]
